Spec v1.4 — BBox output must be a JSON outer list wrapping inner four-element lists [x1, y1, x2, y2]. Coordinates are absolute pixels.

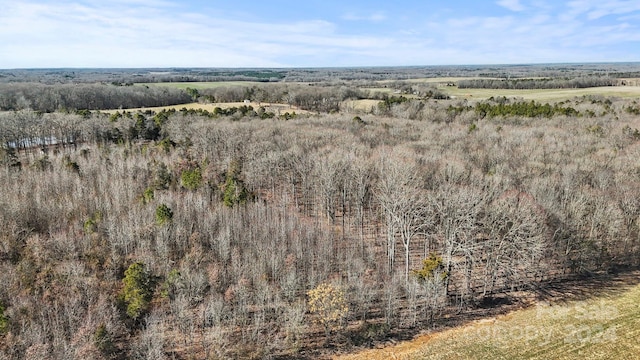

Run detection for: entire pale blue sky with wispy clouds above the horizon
[[0, 0, 640, 68]]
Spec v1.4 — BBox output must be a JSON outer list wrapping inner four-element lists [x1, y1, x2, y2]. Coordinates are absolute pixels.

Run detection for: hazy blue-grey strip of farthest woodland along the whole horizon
[[0, 63, 640, 85]]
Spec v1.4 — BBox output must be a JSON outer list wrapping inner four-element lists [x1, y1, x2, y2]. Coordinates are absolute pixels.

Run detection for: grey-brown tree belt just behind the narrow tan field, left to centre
[[0, 82, 430, 113]]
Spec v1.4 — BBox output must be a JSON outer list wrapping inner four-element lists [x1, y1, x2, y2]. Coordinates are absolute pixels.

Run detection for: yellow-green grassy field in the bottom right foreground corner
[[339, 278, 640, 360]]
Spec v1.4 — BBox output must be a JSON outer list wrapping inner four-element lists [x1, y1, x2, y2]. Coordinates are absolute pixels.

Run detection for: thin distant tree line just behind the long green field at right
[[458, 76, 618, 90]]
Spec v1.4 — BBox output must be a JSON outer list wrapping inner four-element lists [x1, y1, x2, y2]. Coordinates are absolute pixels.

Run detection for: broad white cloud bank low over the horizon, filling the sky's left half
[[0, 1, 388, 67]]
